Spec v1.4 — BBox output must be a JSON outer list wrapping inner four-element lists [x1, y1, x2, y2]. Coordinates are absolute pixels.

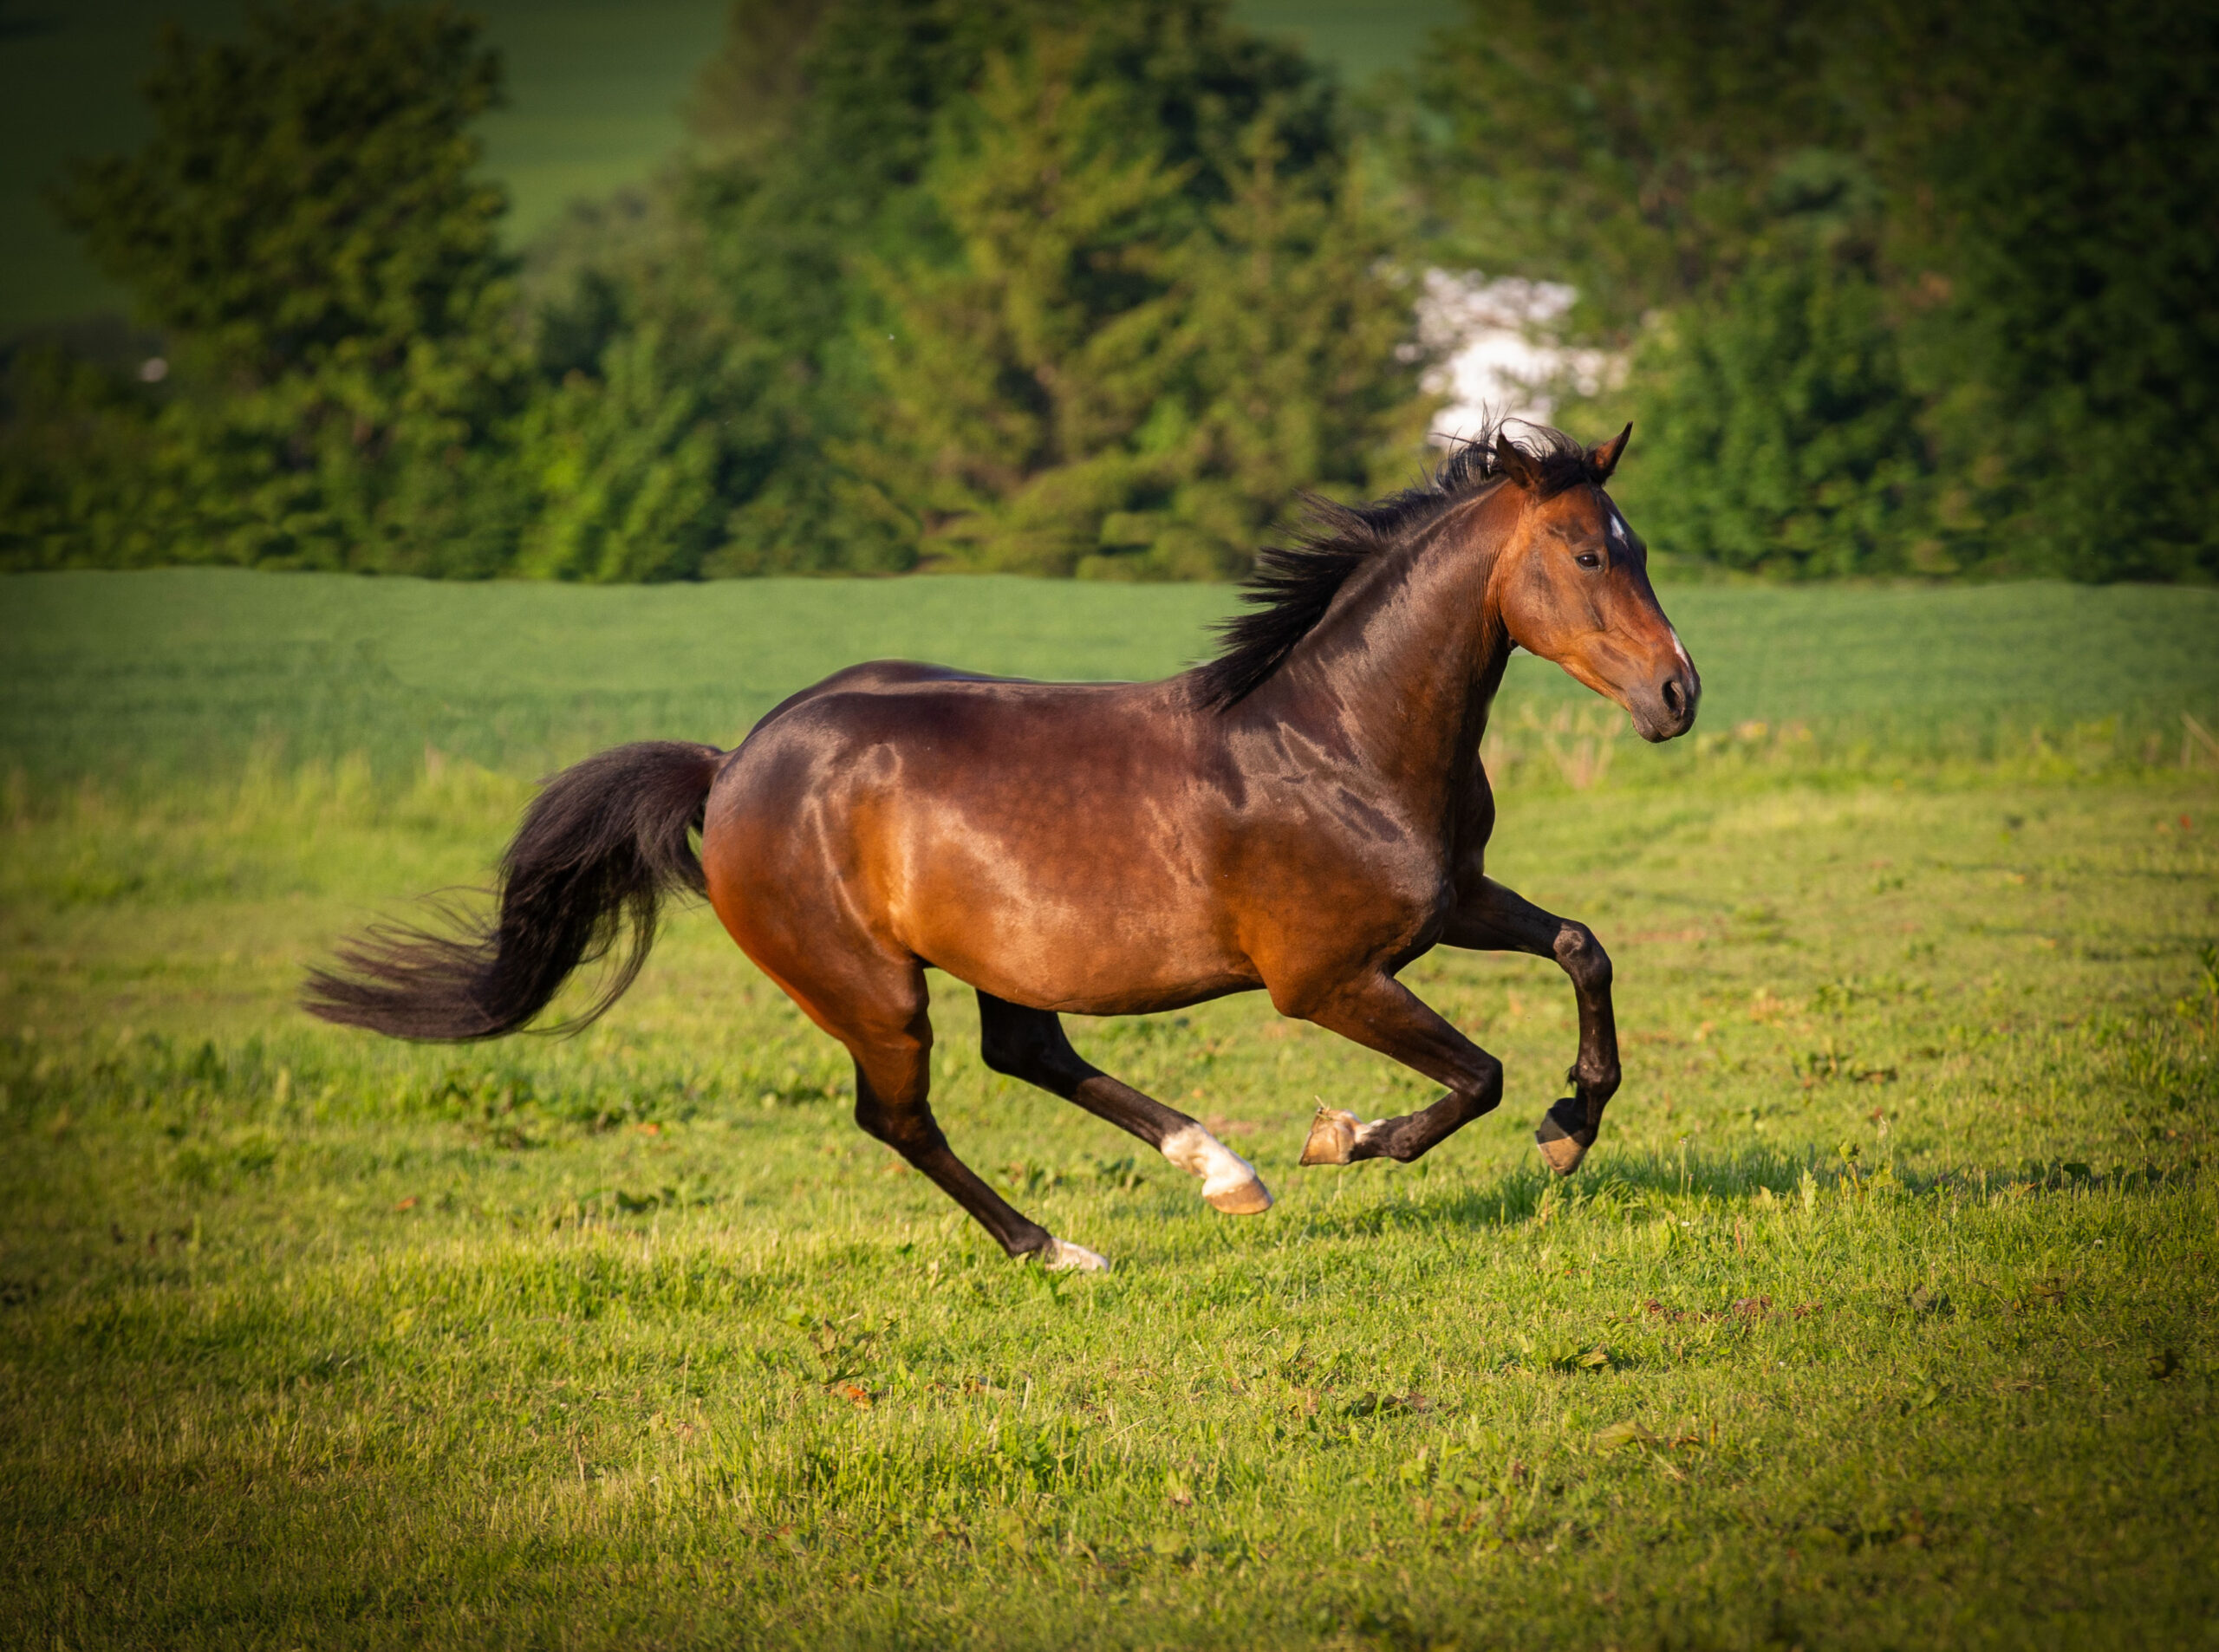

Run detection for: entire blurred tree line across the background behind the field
[[0, 0, 2219, 581]]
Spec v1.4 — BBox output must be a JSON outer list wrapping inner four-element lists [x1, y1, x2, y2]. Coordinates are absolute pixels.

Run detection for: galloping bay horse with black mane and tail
[[304, 426, 1702, 1268]]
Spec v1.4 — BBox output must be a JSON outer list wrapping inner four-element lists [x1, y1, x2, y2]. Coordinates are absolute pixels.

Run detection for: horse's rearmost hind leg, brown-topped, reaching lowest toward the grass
[[788, 962, 1110, 1271]]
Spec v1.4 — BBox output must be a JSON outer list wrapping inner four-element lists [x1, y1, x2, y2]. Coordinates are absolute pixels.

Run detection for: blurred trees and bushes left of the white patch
[[0, 0, 1427, 581]]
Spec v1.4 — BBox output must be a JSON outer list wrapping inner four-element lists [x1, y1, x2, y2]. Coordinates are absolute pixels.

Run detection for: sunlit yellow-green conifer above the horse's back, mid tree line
[[849, 36, 1185, 575]]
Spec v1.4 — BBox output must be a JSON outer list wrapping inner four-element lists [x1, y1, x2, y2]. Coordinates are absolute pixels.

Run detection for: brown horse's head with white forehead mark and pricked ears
[[1491, 426, 1702, 741]]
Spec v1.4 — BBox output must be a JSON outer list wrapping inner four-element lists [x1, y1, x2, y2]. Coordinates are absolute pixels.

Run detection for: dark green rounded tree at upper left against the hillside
[[55, 0, 522, 572]]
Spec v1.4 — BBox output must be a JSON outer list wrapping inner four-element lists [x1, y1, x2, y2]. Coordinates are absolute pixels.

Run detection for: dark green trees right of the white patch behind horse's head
[[1409, 0, 2219, 579]]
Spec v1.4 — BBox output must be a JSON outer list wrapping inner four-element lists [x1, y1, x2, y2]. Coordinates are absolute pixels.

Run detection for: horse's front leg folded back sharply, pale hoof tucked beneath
[[1273, 973, 1502, 1164]]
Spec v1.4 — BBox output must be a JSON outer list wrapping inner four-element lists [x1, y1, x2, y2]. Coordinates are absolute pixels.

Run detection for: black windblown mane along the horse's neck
[[1194, 421, 1596, 712]]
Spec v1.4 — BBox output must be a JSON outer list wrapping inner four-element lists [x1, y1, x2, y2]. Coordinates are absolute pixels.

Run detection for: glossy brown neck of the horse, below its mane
[[1265, 510, 1511, 814]]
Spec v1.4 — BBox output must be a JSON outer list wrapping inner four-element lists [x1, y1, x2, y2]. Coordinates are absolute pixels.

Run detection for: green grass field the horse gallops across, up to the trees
[[0, 572, 2219, 1648]]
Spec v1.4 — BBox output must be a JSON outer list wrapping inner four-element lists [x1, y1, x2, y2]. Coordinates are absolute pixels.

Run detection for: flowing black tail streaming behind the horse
[[302, 741, 724, 1042]]
